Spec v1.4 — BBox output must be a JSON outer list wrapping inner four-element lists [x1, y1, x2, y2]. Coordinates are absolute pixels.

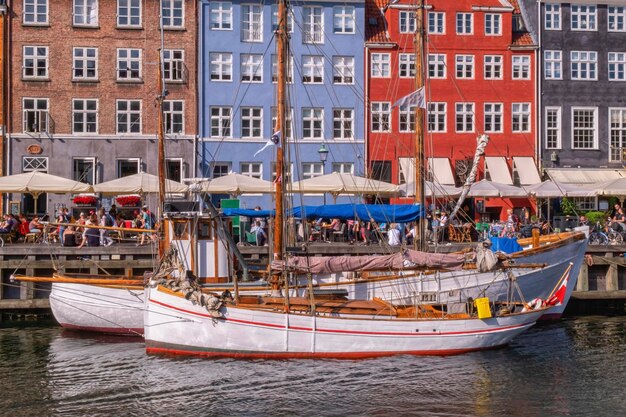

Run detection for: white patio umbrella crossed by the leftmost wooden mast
[[93, 172, 187, 195]]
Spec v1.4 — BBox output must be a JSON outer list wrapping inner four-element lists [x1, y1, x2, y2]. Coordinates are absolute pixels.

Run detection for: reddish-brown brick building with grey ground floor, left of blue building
[[6, 0, 197, 214]]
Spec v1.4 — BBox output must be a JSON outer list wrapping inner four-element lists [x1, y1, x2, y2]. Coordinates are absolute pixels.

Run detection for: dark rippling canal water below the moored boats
[[0, 316, 626, 417]]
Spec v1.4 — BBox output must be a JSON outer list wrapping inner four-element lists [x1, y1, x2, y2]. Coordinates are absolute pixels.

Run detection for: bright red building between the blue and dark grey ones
[[365, 0, 539, 218]]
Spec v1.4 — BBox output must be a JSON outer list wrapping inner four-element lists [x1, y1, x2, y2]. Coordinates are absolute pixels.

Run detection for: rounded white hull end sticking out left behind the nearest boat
[[50, 282, 145, 336]]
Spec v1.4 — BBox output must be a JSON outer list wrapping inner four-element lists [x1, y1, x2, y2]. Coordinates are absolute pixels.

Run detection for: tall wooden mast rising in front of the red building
[[415, 0, 426, 250]]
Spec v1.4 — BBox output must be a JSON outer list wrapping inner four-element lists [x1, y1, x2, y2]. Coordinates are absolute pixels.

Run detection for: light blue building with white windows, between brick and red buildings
[[198, 0, 365, 208]]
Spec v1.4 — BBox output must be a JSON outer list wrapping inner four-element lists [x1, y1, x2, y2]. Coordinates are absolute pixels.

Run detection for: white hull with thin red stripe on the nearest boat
[[144, 287, 543, 358]]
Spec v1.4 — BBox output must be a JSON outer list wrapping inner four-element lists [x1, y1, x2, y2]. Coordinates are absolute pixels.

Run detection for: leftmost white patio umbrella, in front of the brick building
[[0, 171, 92, 214]]
